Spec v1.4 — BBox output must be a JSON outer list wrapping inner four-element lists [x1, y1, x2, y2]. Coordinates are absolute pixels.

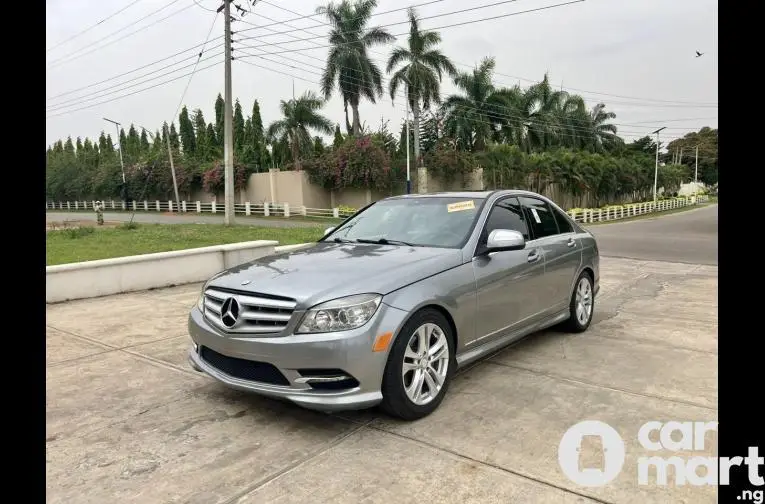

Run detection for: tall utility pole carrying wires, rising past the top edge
[[218, 0, 234, 225]]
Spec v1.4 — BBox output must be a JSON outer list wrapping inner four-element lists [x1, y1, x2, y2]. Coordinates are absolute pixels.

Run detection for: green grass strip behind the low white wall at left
[[46, 224, 324, 266]]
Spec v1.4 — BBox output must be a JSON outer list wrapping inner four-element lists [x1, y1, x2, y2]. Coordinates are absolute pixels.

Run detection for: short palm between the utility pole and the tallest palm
[[266, 91, 334, 170]]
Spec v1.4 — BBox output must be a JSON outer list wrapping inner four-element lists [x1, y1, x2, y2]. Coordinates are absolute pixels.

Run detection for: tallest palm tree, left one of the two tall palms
[[316, 0, 394, 135]]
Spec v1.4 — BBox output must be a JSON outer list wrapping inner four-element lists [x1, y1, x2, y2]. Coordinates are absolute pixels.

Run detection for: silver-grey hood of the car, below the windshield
[[207, 242, 462, 309]]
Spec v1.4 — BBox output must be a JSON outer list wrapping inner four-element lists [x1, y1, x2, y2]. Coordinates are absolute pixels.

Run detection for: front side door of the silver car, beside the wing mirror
[[468, 197, 547, 345]]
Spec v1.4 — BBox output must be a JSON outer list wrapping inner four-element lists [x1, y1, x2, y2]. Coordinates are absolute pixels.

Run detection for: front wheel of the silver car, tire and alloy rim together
[[382, 310, 454, 420]]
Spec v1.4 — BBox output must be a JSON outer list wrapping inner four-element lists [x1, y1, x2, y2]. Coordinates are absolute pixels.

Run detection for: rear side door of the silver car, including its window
[[520, 196, 582, 313]]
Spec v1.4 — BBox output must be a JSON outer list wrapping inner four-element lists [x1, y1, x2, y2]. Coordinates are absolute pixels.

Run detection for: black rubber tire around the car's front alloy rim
[[380, 308, 457, 420]]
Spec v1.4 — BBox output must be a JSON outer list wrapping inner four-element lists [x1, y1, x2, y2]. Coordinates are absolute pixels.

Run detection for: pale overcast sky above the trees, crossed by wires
[[46, 0, 718, 152]]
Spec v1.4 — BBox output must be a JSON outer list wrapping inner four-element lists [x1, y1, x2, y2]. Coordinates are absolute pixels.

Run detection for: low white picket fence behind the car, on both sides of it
[[45, 195, 708, 224]]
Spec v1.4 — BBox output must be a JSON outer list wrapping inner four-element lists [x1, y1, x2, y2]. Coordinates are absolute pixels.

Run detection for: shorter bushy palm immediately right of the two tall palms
[[444, 58, 510, 151]]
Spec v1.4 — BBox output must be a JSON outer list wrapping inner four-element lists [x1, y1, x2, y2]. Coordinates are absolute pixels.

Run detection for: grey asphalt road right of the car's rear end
[[589, 204, 717, 266]]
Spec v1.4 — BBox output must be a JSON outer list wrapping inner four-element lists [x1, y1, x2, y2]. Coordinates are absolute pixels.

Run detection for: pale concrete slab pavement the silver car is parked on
[[46, 215, 717, 504]]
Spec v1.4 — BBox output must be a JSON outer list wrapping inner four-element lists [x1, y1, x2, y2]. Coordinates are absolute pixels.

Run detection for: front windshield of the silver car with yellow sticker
[[325, 197, 482, 248]]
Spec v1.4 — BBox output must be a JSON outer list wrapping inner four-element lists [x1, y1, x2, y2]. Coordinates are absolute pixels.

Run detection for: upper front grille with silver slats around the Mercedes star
[[205, 288, 297, 334]]
